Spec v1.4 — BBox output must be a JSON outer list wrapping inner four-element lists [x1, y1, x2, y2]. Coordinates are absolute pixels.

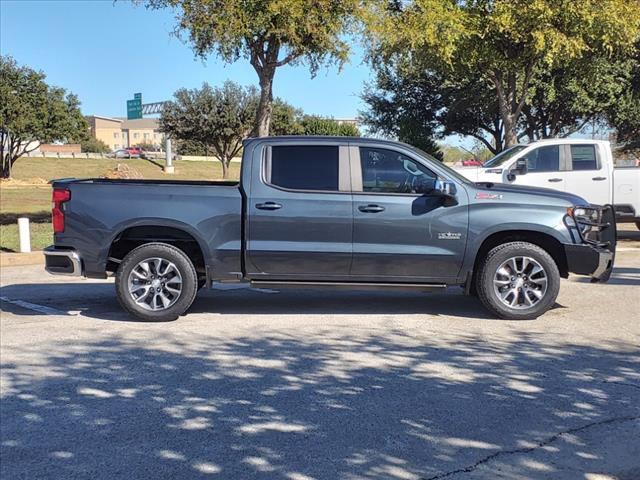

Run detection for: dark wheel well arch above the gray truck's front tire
[[473, 230, 569, 278]]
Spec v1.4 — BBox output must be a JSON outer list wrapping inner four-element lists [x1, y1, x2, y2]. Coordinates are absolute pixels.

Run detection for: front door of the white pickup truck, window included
[[505, 145, 566, 191]]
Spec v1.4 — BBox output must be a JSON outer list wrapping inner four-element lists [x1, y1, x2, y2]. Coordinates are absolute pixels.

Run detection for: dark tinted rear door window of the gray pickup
[[270, 145, 338, 191]]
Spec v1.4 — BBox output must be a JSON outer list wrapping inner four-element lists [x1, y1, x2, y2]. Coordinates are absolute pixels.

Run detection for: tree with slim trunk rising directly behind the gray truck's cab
[[140, 0, 359, 136]]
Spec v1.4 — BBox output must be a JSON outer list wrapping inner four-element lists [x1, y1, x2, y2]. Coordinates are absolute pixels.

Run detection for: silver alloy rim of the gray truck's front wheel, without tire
[[493, 257, 547, 310]]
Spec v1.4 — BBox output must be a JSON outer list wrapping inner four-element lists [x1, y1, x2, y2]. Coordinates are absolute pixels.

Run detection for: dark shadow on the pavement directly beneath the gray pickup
[[0, 282, 500, 321]]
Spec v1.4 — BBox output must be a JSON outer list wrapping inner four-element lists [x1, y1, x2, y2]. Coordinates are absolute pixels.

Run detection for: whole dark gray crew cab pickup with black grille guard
[[45, 137, 616, 321]]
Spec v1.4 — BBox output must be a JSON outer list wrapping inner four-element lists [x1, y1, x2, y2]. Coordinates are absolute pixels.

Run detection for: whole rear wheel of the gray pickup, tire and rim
[[116, 243, 198, 322]]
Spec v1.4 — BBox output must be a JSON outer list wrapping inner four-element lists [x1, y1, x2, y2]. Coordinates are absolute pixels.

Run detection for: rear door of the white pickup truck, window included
[[563, 143, 613, 205]]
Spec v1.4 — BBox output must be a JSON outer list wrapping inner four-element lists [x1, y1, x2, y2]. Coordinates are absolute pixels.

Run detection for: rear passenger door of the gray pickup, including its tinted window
[[245, 141, 353, 280]]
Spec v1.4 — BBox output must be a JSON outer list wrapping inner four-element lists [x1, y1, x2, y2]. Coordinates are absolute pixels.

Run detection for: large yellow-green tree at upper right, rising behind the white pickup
[[366, 0, 640, 149]]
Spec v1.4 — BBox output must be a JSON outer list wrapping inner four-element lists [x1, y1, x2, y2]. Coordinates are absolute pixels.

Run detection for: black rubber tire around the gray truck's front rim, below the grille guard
[[476, 242, 560, 320]]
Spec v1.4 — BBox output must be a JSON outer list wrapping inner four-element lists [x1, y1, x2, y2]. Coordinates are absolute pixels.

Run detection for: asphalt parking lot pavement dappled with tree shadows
[[0, 230, 640, 480]]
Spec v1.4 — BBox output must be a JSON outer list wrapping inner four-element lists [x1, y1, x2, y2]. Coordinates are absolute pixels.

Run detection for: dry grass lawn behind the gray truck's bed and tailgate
[[0, 158, 240, 251]]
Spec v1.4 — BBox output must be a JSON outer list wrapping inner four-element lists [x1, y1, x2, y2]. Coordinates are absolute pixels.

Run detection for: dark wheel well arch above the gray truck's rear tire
[[106, 225, 206, 277]]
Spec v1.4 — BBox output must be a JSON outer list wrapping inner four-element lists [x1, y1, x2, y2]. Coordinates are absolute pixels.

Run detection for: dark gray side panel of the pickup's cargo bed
[[51, 178, 242, 278]]
